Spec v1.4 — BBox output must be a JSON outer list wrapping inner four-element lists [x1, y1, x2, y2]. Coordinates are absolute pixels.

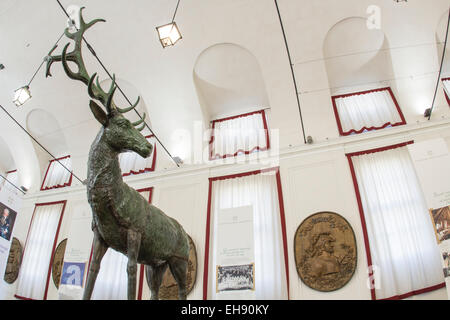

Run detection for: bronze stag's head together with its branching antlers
[[46, 7, 153, 158]]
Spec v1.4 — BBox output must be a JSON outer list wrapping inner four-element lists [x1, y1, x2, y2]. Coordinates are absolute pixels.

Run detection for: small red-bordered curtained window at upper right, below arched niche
[[332, 87, 406, 136]]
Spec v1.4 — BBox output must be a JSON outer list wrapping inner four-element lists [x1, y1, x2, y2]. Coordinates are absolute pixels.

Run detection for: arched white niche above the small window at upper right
[[323, 17, 393, 95]]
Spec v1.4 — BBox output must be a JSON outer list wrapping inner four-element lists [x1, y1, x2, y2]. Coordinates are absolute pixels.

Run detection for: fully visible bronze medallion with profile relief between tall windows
[[294, 212, 357, 292]]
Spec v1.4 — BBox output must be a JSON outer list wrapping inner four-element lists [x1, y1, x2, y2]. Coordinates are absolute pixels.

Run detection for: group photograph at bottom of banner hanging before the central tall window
[[216, 263, 255, 292]]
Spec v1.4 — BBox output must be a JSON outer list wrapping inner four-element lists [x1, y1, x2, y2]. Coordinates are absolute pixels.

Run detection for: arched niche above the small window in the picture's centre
[[193, 43, 269, 122]]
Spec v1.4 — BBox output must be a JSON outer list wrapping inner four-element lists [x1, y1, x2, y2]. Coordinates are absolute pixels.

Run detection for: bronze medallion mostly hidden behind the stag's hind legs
[[159, 235, 197, 300]]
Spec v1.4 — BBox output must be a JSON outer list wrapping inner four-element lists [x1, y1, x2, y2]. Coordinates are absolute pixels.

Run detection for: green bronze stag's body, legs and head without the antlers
[[84, 113, 189, 299]]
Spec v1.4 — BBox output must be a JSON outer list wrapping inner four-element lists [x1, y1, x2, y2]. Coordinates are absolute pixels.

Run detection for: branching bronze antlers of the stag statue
[[46, 7, 145, 130]]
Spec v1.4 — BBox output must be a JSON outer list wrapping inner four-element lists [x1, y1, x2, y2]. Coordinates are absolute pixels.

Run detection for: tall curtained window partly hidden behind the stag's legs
[[92, 188, 153, 300]]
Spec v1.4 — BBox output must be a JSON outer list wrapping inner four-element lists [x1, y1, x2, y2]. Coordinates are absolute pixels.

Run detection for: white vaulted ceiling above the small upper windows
[[0, 0, 450, 191]]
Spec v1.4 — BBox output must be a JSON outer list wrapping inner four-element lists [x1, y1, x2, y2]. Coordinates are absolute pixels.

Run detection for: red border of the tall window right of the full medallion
[[346, 141, 445, 300]]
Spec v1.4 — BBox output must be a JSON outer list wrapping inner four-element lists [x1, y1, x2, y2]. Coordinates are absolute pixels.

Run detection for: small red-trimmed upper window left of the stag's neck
[[41, 156, 72, 190]]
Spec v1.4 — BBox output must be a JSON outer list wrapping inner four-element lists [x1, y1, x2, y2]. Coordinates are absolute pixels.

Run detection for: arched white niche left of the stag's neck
[[27, 109, 70, 182]]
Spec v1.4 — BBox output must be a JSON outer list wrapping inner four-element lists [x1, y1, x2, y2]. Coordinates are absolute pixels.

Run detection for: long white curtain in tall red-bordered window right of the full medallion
[[352, 147, 444, 299]]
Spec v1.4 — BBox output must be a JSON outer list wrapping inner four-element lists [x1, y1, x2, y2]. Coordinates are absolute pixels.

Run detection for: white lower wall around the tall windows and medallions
[[1, 118, 450, 299]]
